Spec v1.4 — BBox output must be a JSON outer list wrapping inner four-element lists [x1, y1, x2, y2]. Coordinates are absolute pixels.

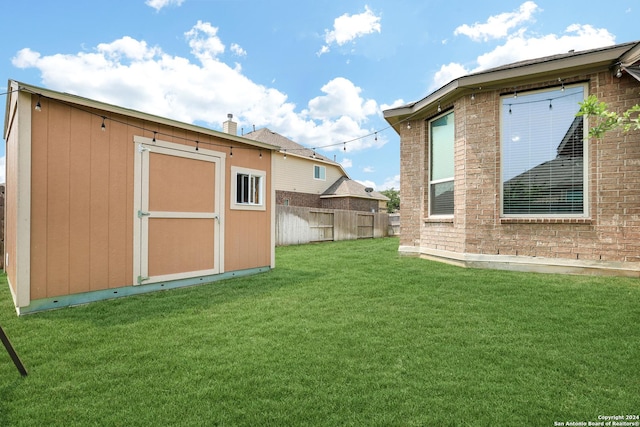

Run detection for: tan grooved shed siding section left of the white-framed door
[[31, 101, 133, 299]]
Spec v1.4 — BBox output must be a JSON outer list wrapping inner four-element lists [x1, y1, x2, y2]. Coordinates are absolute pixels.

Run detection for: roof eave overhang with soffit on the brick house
[[383, 41, 640, 133]]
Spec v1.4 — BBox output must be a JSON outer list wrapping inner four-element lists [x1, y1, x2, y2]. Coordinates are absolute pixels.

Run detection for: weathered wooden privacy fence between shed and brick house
[[276, 205, 389, 246]]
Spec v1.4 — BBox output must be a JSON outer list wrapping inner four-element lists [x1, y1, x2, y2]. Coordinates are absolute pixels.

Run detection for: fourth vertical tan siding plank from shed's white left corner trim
[[89, 116, 111, 290]]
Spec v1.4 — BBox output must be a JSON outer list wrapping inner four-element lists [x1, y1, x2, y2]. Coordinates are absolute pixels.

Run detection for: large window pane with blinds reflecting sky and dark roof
[[501, 85, 587, 217]]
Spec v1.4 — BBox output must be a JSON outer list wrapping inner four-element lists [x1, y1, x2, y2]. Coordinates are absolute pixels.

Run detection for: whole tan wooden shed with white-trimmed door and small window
[[4, 81, 276, 314]]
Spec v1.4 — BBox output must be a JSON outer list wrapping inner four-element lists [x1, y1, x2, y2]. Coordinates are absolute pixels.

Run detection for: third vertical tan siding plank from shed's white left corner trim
[[68, 110, 91, 293]]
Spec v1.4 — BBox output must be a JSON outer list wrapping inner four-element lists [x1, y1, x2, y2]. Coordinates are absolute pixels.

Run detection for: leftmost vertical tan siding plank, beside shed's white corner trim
[[31, 99, 49, 300]]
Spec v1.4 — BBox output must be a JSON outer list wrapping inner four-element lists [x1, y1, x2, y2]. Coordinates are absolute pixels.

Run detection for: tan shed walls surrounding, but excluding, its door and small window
[[6, 87, 273, 314]]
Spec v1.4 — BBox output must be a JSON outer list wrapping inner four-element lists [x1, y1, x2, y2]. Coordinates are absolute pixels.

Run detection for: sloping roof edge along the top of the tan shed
[[5, 80, 280, 151]]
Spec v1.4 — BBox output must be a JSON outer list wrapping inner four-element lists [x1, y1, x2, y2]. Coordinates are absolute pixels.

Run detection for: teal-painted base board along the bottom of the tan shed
[[16, 267, 271, 315]]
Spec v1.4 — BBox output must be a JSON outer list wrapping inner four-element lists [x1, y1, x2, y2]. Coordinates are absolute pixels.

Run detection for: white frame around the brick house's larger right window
[[499, 83, 590, 218]]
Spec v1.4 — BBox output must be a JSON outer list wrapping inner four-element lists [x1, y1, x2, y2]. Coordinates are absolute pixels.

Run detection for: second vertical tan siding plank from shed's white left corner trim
[[47, 105, 71, 297]]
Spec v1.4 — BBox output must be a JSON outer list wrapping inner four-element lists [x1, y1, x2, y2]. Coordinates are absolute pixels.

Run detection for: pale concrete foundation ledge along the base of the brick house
[[398, 246, 640, 278]]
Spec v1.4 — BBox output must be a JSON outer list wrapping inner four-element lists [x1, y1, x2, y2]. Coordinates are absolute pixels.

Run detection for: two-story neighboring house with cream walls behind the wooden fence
[[244, 128, 389, 212]]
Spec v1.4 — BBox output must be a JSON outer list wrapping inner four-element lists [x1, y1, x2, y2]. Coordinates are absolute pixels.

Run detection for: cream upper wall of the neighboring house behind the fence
[[275, 153, 343, 194]]
